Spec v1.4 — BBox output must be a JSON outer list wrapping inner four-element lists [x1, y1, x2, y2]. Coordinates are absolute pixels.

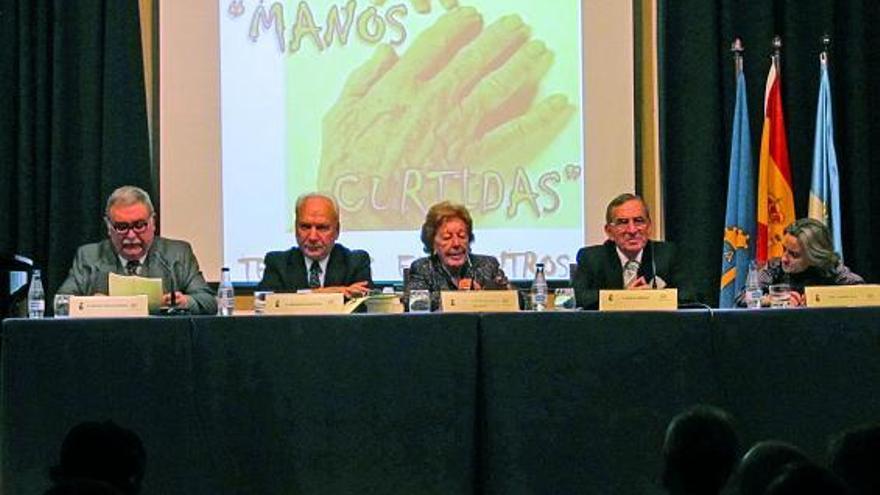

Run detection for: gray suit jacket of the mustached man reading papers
[[58, 237, 217, 314]]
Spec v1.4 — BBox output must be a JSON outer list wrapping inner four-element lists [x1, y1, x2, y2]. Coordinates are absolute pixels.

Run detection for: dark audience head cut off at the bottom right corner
[[829, 424, 880, 495]]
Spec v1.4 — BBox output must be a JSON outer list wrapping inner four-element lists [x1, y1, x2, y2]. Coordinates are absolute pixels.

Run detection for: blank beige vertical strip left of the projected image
[[159, 0, 223, 280]]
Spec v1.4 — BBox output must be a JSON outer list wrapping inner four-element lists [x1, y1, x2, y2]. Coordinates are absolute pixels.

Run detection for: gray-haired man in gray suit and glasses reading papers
[[58, 186, 217, 314]]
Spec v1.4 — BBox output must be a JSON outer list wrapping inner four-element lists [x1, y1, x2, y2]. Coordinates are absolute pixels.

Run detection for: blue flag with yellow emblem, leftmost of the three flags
[[718, 67, 756, 308]]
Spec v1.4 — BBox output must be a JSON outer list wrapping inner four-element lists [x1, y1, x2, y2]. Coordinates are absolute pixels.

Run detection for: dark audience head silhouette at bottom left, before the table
[[49, 421, 146, 495]]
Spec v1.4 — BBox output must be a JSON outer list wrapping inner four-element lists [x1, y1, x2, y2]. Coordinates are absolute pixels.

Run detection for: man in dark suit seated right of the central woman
[[574, 193, 690, 309]]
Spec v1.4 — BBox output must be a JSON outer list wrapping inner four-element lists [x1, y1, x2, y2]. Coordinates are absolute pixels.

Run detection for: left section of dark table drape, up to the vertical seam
[[0, 315, 478, 495]]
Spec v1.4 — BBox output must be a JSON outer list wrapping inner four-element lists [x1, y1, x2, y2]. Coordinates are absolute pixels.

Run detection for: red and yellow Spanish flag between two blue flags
[[755, 58, 795, 262]]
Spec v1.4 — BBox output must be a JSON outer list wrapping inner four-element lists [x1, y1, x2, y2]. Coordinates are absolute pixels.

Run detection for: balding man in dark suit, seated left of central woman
[[257, 193, 373, 297]]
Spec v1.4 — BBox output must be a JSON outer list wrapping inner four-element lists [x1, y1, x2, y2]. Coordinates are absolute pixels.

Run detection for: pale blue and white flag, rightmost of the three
[[809, 57, 843, 257]]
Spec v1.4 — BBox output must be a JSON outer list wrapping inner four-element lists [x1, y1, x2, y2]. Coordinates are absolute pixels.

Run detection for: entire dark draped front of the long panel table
[[0, 309, 880, 494]]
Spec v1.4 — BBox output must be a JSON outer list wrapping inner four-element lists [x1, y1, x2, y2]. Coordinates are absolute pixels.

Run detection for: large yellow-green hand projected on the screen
[[318, 7, 575, 230]]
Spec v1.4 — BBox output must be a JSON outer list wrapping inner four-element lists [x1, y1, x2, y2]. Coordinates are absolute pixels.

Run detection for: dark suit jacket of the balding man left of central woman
[[257, 244, 373, 292]]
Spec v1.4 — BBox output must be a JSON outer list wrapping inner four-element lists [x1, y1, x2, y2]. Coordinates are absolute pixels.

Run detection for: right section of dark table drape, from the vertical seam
[[479, 309, 880, 494]]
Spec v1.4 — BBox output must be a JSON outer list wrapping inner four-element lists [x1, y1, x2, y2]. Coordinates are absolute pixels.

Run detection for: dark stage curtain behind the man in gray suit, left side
[[0, 0, 151, 292]]
